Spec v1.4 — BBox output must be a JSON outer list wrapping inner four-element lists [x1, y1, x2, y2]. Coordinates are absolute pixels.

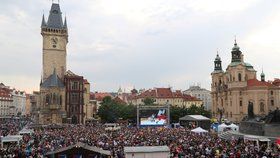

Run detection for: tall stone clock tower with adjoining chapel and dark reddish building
[[38, 3, 90, 124]]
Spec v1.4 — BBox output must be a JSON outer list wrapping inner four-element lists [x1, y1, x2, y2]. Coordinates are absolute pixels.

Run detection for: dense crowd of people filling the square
[[0, 119, 280, 158]]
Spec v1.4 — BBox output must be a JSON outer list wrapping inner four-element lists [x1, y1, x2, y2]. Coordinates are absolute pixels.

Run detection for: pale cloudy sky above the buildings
[[0, 0, 280, 93]]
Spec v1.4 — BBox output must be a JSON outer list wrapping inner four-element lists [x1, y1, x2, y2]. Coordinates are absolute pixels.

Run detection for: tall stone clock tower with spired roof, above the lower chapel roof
[[41, 3, 68, 82]]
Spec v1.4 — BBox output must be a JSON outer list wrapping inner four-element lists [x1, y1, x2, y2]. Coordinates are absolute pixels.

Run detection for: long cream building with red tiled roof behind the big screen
[[128, 88, 203, 108]]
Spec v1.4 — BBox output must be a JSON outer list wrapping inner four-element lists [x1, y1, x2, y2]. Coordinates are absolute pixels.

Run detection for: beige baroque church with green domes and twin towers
[[211, 41, 280, 122]]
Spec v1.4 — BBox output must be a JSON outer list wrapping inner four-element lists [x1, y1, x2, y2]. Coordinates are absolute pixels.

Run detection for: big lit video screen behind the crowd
[[139, 109, 168, 126]]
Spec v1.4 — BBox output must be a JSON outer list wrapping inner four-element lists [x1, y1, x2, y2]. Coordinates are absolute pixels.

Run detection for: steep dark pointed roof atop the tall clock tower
[[47, 3, 63, 29]]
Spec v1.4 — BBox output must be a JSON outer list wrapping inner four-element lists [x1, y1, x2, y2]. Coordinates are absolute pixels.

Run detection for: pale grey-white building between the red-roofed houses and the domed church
[[183, 85, 212, 110]]
